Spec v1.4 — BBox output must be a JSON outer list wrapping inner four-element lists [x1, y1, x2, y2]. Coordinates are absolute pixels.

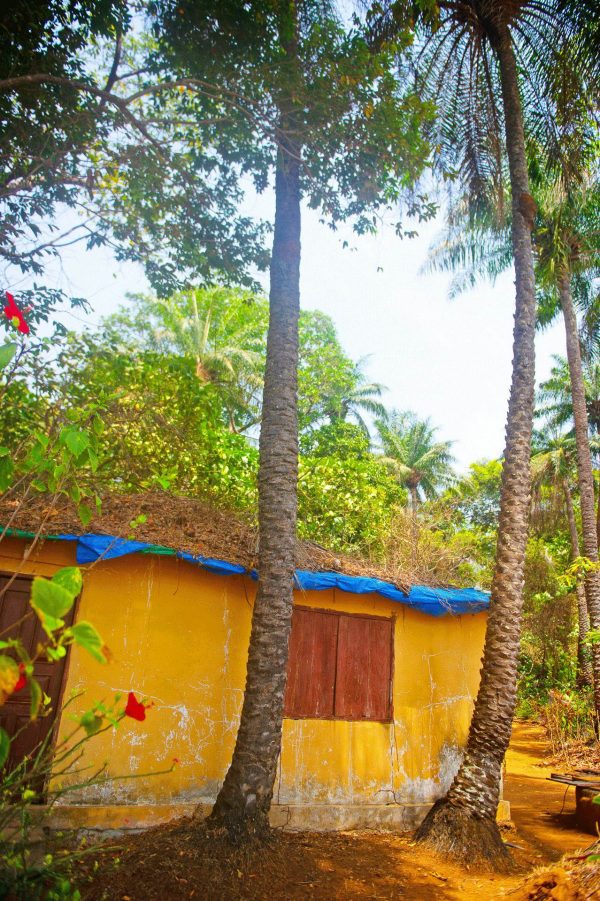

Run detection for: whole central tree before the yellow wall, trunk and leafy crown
[[150, 0, 427, 840]]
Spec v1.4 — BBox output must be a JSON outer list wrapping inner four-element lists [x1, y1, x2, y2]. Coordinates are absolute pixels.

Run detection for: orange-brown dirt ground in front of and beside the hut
[[80, 723, 600, 901]]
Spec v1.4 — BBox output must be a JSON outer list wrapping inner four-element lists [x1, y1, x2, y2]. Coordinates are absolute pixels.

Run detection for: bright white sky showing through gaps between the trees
[[7, 195, 564, 470]]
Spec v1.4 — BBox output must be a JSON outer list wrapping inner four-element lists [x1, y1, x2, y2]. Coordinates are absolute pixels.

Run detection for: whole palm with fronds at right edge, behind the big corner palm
[[430, 183, 600, 721]]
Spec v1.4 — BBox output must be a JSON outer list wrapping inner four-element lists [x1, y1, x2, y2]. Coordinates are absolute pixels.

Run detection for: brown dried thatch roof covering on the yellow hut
[[0, 492, 411, 593]]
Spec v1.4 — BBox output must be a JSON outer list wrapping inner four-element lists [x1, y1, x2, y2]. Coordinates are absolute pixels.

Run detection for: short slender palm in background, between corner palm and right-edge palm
[[531, 435, 592, 685]]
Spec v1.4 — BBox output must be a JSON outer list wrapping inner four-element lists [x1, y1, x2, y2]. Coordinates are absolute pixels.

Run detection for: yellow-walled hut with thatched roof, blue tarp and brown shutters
[[0, 494, 496, 829]]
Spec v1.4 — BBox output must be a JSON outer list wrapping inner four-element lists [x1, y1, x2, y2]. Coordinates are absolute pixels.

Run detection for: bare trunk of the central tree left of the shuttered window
[[209, 10, 301, 840]]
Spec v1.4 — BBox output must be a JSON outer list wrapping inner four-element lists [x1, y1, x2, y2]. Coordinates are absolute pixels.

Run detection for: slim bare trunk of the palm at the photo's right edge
[[558, 270, 600, 723]]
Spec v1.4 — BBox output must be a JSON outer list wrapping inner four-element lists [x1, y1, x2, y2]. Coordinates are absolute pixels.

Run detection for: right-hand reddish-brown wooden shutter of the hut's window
[[335, 615, 392, 720]]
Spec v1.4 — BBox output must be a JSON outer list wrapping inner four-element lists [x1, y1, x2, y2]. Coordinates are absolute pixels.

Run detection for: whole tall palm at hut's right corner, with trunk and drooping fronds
[[373, 0, 598, 866]]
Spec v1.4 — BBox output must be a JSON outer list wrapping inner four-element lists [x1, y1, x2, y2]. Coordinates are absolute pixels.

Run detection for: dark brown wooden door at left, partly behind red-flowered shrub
[[0, 573, 74, 765]]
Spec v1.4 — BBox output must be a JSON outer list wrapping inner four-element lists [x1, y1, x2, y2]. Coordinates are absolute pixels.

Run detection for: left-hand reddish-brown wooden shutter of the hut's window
[[284, 608, 338, 717]]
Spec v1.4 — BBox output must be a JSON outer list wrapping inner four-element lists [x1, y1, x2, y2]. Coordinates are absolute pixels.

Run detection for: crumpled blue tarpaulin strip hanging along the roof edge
[[8, 529, 490, 616]]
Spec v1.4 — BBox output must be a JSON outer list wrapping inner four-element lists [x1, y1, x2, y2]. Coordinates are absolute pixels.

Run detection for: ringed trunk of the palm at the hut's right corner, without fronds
[[417, 26, 536, 869]]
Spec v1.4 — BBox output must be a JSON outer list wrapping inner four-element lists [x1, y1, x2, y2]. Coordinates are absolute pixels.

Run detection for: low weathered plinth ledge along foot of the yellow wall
[[45, 801, 510, 832]]
